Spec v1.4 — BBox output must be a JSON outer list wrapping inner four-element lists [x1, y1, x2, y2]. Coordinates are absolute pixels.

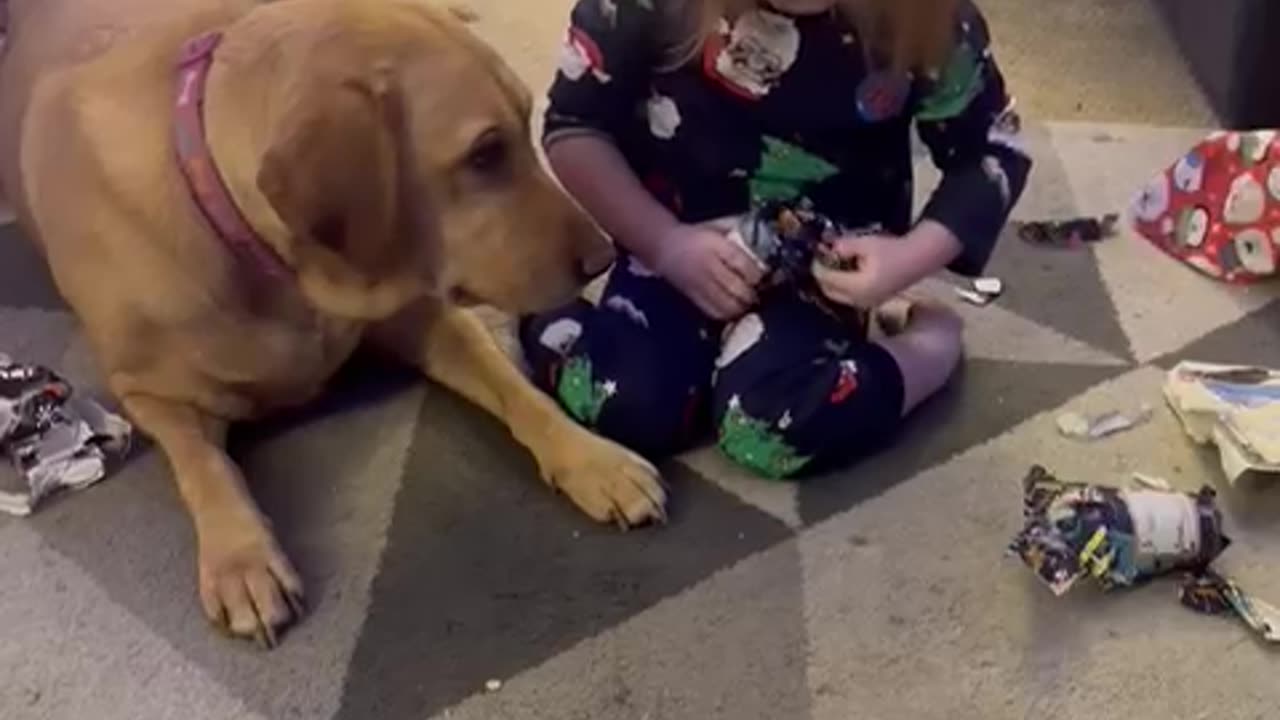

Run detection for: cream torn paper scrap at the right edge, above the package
[[1165, 363, 1280, 483]]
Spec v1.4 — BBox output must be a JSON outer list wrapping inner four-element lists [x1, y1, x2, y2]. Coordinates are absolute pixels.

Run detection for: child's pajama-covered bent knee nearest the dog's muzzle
[[520, 256, 718, 459]]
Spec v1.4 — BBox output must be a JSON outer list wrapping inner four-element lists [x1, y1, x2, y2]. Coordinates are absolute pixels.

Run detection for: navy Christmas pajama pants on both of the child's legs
[[520, 256, 902, 478]]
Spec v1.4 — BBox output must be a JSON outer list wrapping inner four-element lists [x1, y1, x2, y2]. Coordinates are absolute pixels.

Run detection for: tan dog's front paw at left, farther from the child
[[198, 507, 302, 648]]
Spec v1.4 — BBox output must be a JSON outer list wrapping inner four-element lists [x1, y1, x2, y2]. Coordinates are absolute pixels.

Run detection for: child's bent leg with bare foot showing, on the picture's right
[[713, 288, 960, 478]]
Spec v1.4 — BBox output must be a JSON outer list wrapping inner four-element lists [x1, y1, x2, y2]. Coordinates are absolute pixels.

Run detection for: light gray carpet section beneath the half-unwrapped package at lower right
[[799, 368, 1280, 720]]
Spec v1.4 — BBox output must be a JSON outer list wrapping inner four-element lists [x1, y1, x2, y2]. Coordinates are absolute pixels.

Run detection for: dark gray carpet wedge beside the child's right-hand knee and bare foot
[[799, 360, 1126, 525]]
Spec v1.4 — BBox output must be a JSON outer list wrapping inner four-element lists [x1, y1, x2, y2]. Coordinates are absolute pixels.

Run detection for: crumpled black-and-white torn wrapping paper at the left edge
[[0, 354, 132, 515]]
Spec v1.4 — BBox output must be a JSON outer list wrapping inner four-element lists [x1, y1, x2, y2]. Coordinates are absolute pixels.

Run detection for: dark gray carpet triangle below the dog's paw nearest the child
[[339, 391, 791, 720]]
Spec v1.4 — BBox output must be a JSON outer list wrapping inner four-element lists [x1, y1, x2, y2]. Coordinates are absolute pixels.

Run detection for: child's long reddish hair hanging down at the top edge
[[664, 0, 959, 72]]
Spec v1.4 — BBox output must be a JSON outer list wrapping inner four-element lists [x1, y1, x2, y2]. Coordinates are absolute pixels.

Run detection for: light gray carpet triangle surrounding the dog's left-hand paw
[[28, 377, 424, 717]]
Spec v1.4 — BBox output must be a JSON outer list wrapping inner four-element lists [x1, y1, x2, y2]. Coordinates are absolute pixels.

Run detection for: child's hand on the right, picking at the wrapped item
[[813, 220, 961, 309]]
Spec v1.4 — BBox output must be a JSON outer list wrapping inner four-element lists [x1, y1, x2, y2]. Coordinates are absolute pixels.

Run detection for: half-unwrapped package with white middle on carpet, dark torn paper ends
[[1009, 465, 1230, 596]]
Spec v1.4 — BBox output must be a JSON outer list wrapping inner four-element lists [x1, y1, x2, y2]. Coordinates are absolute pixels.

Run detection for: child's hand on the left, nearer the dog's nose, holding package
[[653, 224, 764, 320]]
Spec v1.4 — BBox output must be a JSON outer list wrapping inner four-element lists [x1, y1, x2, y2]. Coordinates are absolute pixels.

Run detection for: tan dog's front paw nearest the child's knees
[[543, 427, 667, 529]]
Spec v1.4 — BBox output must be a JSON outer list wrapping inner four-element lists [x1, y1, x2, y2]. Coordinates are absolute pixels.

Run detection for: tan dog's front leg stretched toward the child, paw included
[[372, 305, 667, 527]]
